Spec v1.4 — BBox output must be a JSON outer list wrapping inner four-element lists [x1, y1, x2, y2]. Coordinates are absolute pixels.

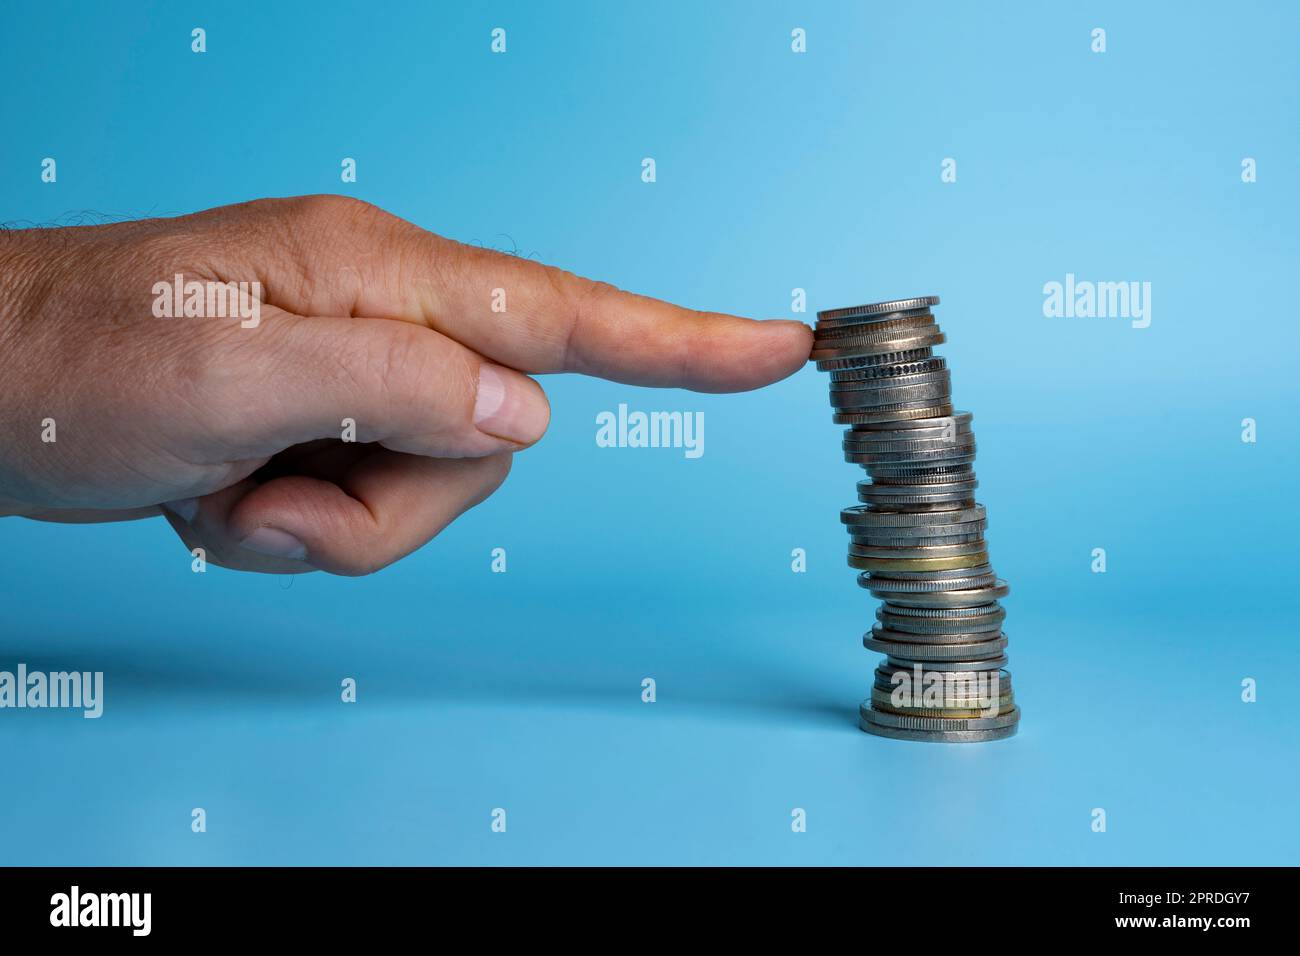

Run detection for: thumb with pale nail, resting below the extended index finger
[[193, 313, 550, 460]]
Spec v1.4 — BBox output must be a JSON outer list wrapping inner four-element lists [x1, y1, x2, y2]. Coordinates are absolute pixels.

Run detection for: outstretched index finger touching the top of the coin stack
[[217, 196, 813, 392]]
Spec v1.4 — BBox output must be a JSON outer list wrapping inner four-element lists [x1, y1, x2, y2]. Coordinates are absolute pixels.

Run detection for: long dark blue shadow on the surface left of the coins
[[0, 645, 861, 732]]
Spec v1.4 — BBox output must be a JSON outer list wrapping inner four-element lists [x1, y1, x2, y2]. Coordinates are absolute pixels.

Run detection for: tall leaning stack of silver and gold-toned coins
[[813, 295, 1021, 743]]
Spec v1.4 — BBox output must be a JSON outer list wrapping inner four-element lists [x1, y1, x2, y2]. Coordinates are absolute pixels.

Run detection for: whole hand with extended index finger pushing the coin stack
[[0, 196, 811, 575]]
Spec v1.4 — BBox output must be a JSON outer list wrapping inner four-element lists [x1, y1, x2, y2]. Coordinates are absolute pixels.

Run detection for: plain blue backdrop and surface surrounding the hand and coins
[[0, 1, 1300, 865]]
